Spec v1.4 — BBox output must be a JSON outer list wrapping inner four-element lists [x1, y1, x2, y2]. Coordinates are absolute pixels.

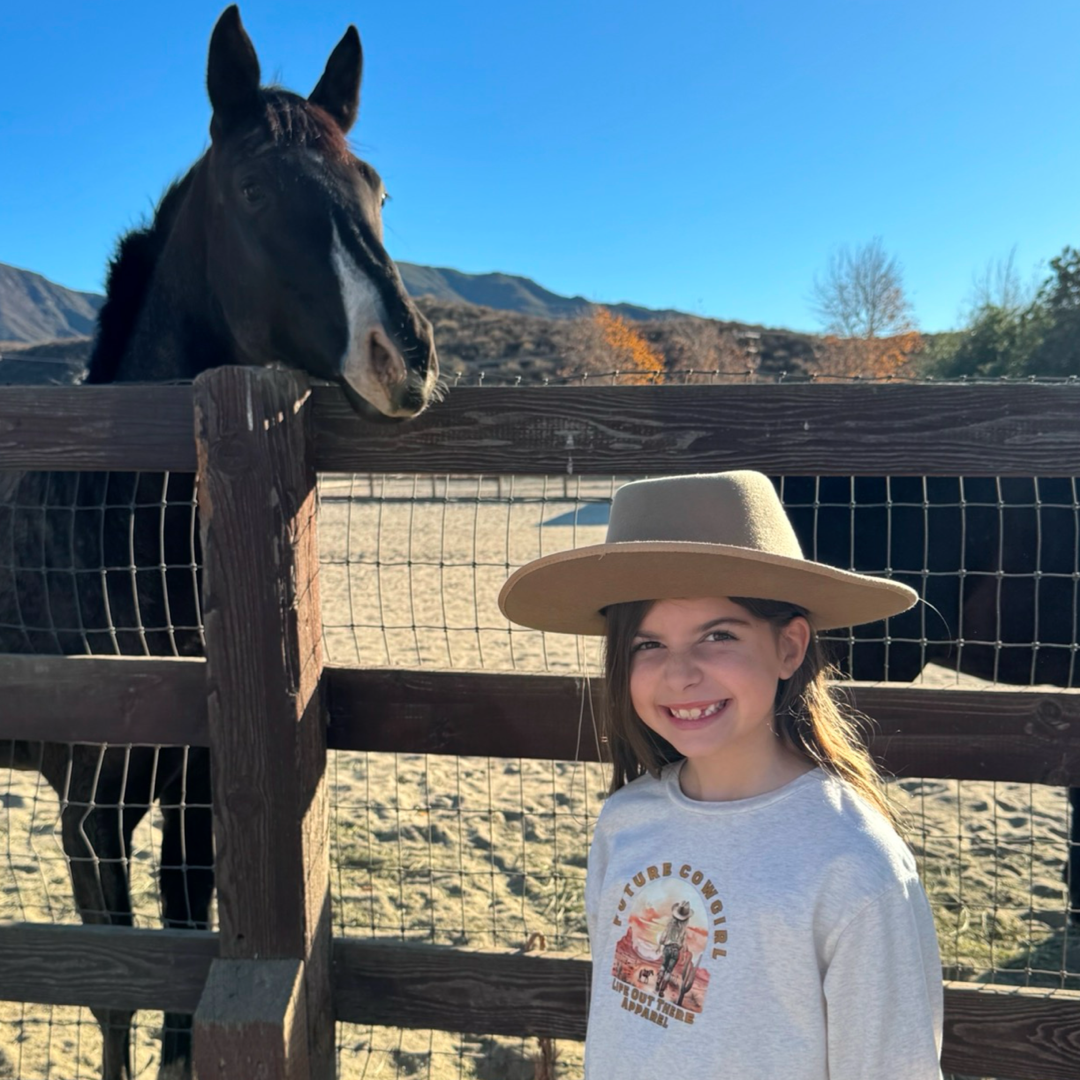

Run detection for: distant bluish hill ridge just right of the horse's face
[[397, 262, 686, 321]]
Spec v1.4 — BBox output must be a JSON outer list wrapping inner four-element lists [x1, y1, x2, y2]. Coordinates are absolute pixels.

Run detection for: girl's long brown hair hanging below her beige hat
[[603, 596, 897, 827]]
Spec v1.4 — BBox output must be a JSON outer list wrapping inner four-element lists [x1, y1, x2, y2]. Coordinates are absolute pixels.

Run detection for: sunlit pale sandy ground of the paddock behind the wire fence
[[0, 477, 1080, 1080]]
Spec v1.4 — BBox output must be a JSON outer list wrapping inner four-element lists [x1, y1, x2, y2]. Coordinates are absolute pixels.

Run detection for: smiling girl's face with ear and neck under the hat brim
[[630, 597, 810, 797]]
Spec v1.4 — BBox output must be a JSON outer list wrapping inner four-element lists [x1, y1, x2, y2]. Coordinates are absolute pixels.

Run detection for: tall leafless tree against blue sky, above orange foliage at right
[[810, 237, 914, 340]]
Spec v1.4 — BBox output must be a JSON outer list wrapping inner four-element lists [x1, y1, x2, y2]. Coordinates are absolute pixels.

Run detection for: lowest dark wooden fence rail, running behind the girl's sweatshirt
[[0, 926, 1080, 1080]]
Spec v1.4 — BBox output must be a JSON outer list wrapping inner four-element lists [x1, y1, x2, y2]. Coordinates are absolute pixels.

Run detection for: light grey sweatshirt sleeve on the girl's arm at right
[[824, 881, 943, 1080]]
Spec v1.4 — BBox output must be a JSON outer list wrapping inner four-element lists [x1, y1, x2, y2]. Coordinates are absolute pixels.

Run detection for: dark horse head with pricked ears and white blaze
[[205, 6, 438, 419]]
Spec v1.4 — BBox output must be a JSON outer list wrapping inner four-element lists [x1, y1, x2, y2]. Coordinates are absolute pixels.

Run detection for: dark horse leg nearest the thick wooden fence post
[[158, 747, 214, 1080]]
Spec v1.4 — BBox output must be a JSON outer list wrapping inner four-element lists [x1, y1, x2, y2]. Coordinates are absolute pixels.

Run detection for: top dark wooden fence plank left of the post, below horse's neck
[[0, 384, 195, 472]]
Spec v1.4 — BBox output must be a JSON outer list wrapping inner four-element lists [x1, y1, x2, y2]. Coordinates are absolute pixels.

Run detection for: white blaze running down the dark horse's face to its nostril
[[330, 225, 407, 416]]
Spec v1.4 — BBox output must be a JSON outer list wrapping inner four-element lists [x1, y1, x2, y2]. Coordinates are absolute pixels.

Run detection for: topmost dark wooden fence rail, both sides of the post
[[0, 383, 1080, 476]]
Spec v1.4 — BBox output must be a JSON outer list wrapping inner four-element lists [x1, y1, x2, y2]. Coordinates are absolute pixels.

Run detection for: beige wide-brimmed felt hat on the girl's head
[[499, 470, 918, 634]]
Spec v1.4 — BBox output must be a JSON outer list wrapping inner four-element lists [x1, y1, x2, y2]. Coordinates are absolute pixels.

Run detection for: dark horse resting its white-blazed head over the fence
[[0, 5, 441, 1080]]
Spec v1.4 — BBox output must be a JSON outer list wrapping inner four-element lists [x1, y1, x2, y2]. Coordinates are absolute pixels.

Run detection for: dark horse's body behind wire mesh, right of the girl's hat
[[782, 476, 1080, 923]]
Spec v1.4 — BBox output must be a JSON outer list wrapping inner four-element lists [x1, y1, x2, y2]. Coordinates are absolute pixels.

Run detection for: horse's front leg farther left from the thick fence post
[[42, 745, 148, 1080]]
